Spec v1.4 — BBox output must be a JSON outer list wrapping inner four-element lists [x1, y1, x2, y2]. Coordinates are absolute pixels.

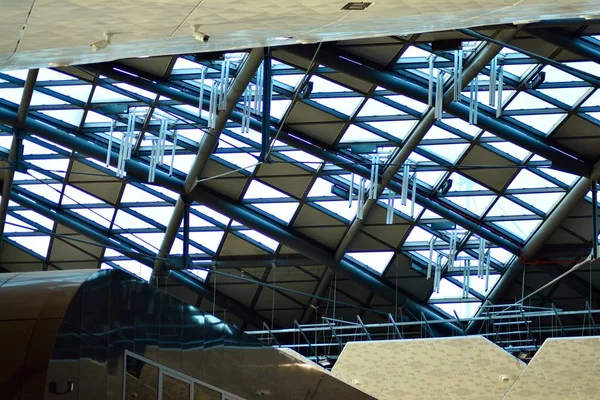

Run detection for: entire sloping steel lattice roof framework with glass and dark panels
[[0, 25, 600, 334]]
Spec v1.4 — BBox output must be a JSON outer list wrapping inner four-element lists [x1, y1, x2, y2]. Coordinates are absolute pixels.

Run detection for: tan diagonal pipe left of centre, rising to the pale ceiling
[[153, 49, 263, 277]]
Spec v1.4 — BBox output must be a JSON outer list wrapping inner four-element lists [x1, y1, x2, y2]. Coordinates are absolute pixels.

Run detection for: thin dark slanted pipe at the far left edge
[[0, 69, 39, 247]]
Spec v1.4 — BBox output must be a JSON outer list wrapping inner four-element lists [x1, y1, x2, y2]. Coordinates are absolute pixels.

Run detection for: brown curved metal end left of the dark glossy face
[[0, 271, 94, 399]]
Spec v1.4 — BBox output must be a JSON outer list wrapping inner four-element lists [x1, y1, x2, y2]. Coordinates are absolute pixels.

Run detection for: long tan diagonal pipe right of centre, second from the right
[[303, 29, 518, 321]]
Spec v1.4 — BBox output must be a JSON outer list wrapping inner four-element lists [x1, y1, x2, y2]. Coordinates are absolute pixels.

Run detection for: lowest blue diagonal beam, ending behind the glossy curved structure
[[10, 184, 269, 327]]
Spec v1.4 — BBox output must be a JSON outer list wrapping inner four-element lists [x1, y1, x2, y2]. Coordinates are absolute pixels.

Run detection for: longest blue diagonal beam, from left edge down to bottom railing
[[0, 108, 462, 335]]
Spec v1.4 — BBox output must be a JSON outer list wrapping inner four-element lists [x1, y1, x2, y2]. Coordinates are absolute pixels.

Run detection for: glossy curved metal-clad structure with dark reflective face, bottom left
[[0, 270, 371, 400]]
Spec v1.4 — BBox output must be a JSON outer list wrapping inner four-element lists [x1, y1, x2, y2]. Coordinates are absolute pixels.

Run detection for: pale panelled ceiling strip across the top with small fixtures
[[0, 0, 600, 71]]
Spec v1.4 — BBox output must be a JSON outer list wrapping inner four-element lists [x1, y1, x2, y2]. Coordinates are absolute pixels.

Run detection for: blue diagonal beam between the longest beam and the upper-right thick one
[[86, 64, 521, 254]]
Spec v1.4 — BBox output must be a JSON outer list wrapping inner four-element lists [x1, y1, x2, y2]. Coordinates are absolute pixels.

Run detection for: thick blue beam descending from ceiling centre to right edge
[[286, 46, 591, 176]]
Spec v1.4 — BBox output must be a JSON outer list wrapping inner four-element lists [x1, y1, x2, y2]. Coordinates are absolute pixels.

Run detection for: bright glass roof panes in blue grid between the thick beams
[[0, 32, 600, 328]]
